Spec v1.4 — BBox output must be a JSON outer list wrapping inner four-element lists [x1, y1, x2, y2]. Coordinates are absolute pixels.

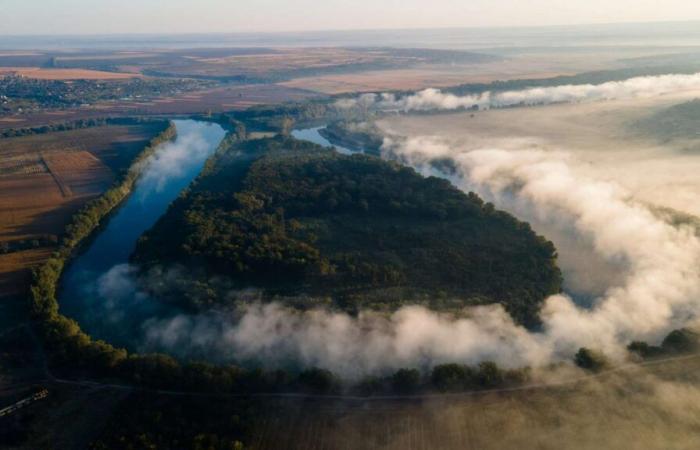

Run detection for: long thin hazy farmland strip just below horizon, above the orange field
[[0, 47, 499, 81]]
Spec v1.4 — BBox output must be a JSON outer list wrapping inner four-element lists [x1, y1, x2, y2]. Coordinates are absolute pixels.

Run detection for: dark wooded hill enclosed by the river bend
[[132, 137, 561, 325]]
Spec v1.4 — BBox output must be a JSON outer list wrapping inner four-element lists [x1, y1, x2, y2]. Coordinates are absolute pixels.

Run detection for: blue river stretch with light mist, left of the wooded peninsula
[[59, 120, 226, 341]]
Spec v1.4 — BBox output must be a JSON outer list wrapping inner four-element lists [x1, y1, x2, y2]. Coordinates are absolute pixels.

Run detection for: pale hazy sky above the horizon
[[0, 0, 700, 35]]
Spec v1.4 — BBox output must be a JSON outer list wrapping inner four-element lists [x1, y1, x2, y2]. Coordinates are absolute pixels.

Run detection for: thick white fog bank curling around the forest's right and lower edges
[[124, 133, 700, 377]]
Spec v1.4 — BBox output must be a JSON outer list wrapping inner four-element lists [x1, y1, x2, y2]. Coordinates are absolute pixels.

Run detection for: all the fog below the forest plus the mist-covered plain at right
[[82, 73, 700, 377]]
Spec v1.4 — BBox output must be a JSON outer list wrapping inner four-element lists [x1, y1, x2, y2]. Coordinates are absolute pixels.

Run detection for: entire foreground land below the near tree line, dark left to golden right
[[0, 354, 700, 450]]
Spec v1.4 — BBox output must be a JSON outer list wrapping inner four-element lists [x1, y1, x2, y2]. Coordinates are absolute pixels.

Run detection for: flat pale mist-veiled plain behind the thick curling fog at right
[[380, 90, 700, 215]]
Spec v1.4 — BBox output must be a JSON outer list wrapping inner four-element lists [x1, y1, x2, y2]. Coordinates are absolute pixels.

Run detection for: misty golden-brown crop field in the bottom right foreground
[[249, 356, 700, 450]]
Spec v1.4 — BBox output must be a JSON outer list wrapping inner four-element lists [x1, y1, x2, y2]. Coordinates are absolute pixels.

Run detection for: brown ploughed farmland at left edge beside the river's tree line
[[0, 124, 165, 307]]
